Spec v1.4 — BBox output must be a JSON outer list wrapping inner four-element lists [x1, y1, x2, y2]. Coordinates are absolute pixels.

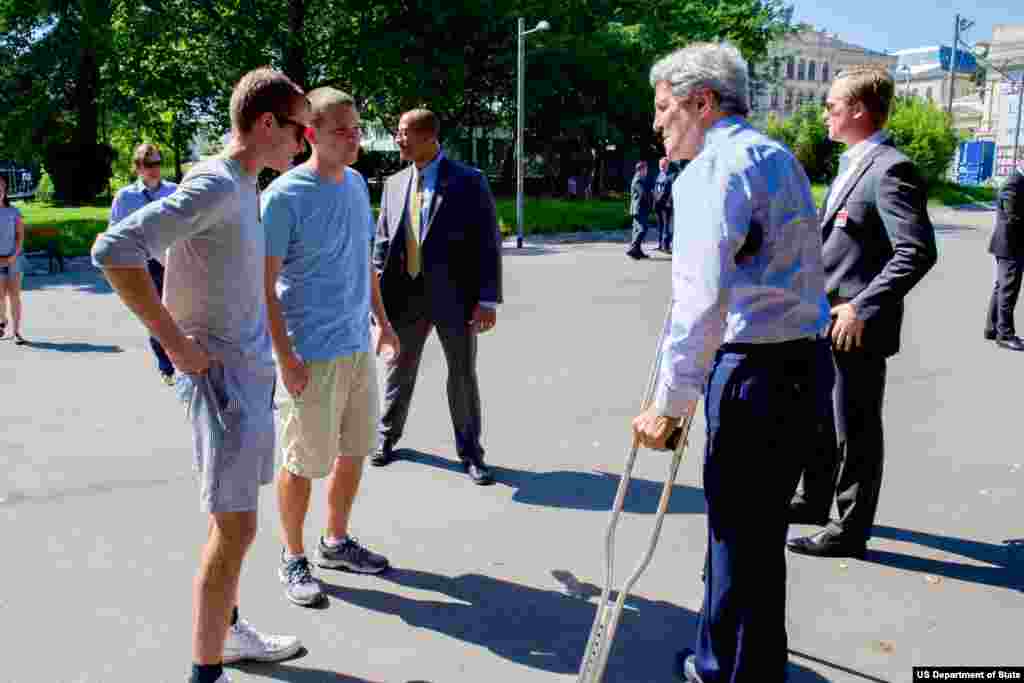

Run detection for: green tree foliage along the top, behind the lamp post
[[0, 0, 790, 201]]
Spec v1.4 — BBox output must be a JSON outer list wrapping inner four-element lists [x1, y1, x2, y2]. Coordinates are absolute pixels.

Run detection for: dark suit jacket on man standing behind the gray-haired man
[[820, 140, 938, 356]]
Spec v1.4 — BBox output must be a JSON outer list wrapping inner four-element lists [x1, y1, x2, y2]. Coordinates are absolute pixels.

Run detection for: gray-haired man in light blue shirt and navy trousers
[[633, 43, 834, 683]]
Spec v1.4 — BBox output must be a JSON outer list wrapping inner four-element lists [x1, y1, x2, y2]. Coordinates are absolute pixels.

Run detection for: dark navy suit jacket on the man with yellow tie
[[374, 157, 502, 326]]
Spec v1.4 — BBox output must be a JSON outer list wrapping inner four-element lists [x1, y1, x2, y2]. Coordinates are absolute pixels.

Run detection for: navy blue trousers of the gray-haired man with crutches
[[696, 340, 834, 683]]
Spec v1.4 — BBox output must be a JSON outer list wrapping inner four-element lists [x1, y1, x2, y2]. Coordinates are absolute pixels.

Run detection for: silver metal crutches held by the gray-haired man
[[577, 303, 693, 683]]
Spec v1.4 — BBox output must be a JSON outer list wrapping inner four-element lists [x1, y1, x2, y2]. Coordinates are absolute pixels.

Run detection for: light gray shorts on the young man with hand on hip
[[175, 362, 274, 512]]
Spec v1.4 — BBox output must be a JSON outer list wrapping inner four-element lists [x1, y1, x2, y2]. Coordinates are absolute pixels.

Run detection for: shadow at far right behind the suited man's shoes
[[865, 525, 1024, 591]]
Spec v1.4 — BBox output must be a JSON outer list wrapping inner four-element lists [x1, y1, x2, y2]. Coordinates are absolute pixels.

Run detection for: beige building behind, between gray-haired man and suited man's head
[[753, 29, 896, 119]]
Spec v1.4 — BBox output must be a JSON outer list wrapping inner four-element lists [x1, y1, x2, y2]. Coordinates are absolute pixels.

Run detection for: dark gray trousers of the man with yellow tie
[[380, 280, 483, 462]]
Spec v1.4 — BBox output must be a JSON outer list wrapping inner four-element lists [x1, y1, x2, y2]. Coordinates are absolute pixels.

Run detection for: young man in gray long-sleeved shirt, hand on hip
[[92, 69, 309, 683]]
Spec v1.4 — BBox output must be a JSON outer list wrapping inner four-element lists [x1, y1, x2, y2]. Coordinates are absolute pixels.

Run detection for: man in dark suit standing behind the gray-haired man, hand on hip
[[787, 66, 937, 557]]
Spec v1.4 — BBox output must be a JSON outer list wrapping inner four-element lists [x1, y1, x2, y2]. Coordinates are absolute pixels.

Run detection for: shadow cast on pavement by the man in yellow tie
[[395, 449, 705, 515]]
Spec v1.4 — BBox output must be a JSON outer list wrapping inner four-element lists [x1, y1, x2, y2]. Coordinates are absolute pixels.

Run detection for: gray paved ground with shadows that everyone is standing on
[[0, 205, 1024, 683]]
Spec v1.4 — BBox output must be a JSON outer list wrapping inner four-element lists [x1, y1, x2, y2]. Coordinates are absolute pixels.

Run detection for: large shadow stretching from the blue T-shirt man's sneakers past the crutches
[[323, 569, 825, 683]]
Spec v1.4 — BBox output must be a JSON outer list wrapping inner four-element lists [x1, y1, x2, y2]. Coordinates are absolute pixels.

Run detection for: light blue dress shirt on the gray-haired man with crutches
[[655, 117, 828, 417]]
